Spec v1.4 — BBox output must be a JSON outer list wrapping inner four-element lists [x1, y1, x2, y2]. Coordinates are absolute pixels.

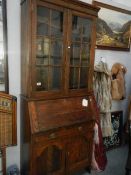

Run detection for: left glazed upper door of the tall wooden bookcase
[[32, 2, 66, 97]]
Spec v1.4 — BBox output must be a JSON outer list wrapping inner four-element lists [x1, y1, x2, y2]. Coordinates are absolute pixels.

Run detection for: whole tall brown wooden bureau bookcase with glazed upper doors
[[21, 0, 99, 175]]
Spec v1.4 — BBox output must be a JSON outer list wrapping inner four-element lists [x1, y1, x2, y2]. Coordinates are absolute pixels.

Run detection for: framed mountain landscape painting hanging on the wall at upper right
[[93, 1, 131, 51]]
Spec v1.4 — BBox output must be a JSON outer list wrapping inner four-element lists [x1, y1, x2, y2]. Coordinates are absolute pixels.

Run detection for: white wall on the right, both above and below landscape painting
[[92, 0, 131, 123]]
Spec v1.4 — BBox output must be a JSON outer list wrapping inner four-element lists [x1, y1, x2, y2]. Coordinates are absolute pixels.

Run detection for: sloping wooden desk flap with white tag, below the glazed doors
[[28, 97, 94, 133]]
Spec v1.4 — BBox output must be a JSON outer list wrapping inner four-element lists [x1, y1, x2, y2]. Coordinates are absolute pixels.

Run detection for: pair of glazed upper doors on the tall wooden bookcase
[[31, 1, 95, 98]]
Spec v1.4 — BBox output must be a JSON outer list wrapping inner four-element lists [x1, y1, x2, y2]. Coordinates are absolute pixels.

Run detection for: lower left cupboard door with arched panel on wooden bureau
[[31, 143, 65, 175]]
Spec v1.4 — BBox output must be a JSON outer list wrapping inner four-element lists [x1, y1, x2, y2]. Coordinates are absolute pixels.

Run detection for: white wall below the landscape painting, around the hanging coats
[[95, 50, 131, 123]]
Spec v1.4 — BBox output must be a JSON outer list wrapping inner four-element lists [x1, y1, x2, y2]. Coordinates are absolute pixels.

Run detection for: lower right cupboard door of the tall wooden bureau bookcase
[[67, 136, 92, 172]]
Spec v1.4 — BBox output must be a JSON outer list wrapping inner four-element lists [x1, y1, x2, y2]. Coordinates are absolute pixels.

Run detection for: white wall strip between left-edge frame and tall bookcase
[[7, 0, 20, 171]]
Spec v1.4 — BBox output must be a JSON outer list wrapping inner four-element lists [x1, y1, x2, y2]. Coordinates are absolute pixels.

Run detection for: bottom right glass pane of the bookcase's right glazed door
[[80, 67, 88, 88]]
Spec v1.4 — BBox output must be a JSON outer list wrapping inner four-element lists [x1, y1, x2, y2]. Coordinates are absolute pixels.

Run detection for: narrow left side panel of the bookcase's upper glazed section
[[21, 1, 31, 96]]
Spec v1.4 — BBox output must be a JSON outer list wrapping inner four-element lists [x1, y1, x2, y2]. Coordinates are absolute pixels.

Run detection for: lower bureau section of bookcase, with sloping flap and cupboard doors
[[22, 97, 95, 175]]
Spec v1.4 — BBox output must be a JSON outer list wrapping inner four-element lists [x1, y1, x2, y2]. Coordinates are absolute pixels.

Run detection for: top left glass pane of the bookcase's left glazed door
[[37, 6, 50, 35]]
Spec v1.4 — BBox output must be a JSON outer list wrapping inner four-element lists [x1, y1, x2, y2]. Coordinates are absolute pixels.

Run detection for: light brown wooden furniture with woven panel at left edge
[[0, 92, 17, 175]]
